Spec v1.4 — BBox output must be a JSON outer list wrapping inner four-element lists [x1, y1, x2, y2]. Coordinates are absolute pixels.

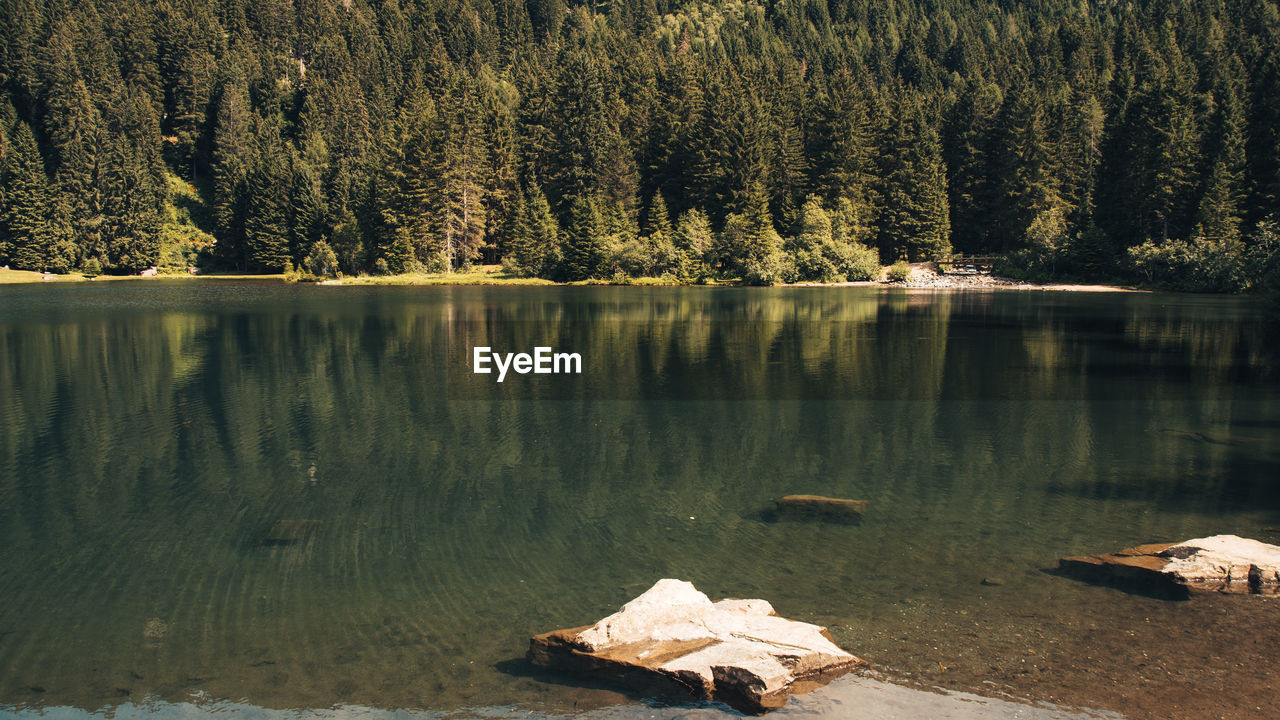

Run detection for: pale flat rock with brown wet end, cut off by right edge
[[1059, 536, 1280, 594]]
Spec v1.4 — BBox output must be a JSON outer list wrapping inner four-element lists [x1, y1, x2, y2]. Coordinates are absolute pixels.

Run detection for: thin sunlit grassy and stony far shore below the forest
[[0, 263, 1149, 292]]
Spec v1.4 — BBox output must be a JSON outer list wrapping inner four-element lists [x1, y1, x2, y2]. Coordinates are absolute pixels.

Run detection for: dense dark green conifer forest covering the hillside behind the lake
[[0, 0, 1280, 290]]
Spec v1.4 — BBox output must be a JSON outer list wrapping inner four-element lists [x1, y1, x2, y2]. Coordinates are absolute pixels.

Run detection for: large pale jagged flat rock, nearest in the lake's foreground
[[529, 579, 864, 714]]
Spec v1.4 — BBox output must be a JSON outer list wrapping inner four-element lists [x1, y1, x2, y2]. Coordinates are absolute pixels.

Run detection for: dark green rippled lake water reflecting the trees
[[0, 281, 1280, 717]]
